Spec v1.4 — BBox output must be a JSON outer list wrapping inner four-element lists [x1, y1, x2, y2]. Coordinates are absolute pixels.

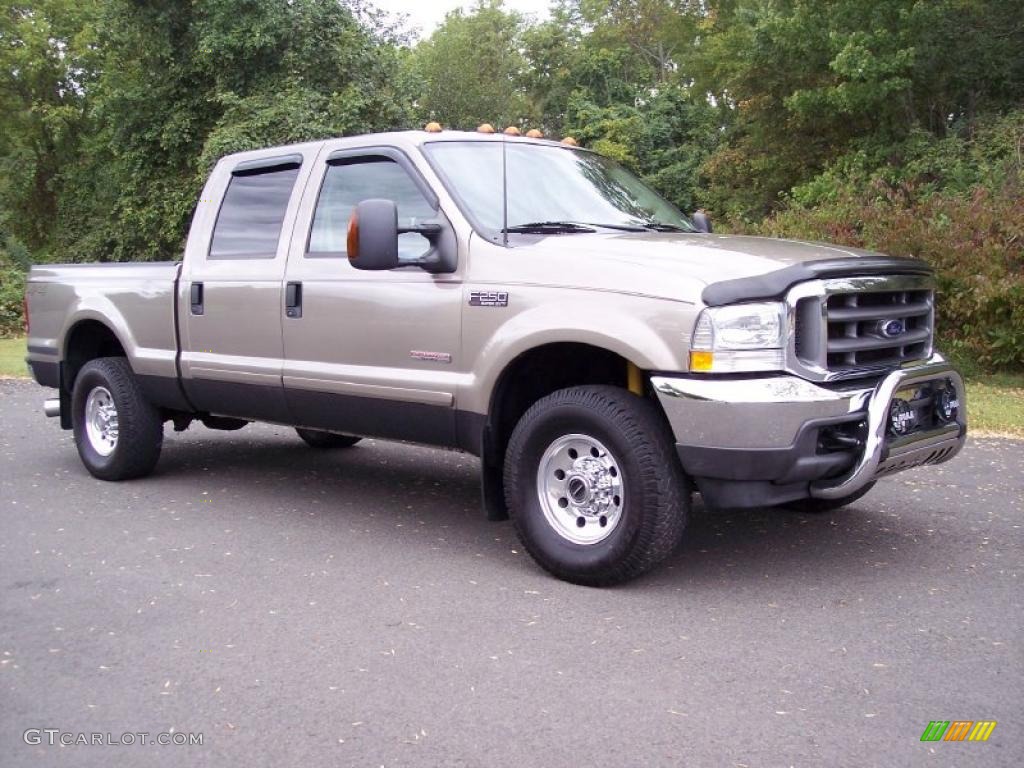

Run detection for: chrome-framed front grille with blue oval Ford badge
[[788, 275, 935, 379]]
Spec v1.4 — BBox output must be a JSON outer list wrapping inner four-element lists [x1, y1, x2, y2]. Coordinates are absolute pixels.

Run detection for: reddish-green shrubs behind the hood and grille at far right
[[756, 112, 1024, 369]]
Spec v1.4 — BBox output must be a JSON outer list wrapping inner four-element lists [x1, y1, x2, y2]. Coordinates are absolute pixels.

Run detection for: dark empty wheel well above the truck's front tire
[[483, 343, 630, 462]]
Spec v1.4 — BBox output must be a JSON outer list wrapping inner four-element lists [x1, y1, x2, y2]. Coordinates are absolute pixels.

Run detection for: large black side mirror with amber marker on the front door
[[346, 200, 455, 272]]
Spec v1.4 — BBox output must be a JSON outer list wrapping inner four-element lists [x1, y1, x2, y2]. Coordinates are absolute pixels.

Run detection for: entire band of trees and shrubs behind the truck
[[0, 0, 1024, 367]]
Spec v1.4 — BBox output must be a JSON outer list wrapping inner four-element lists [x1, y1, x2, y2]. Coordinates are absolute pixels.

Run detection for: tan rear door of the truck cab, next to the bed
[[178, 145, 318, 422]]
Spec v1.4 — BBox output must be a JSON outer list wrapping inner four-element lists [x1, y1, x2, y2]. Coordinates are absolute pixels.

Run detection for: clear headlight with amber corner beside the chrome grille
[[690, 301, 785, 374]]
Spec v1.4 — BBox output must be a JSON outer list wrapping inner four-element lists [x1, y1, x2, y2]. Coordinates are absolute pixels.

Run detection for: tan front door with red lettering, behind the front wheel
[[284, 147, 462, 444]]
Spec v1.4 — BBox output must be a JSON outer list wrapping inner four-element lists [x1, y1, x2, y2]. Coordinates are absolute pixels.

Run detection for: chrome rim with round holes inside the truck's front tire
[[537, 434, 626, 545]]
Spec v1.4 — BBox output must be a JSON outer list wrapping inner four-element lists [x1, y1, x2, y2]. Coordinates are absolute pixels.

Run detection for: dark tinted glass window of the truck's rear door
[[210, 166, 299, 259]]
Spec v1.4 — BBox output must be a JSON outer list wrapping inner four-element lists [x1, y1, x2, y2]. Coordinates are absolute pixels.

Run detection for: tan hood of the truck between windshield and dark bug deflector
[[513, 232, 928, 303]]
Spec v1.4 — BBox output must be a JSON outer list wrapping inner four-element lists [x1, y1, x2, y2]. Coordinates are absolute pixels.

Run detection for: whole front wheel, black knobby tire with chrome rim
[[505, 386, 690, 586]]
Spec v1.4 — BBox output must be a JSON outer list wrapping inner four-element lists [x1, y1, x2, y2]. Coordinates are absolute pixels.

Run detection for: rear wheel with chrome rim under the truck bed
[[71, 357, 164, 480]]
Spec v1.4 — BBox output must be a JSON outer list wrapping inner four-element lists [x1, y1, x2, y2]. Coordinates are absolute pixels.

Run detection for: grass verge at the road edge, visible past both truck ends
[[0, 338, 1024, 437]]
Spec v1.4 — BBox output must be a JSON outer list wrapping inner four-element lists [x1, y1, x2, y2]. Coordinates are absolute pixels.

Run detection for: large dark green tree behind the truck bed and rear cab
[[59, 0, 409, 260]]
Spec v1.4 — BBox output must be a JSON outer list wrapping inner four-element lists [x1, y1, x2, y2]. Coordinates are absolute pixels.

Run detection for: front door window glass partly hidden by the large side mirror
[[309, 158, 437, 260]]
